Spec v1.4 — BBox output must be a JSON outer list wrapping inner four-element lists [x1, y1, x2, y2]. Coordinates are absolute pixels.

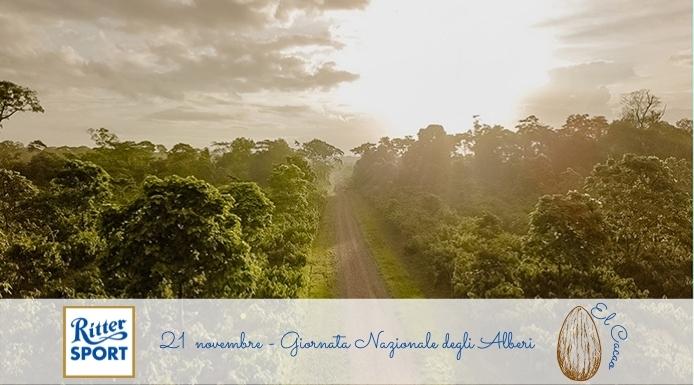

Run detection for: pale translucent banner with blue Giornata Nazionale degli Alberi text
[[0, 299, 692, 384]]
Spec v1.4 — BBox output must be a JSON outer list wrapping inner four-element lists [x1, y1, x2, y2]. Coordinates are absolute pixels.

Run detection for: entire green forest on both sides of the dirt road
[[0, 82, 692, 298]]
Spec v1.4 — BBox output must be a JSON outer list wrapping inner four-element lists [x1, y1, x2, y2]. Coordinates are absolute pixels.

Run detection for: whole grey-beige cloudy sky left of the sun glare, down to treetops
[[0, 0, 378, 146]]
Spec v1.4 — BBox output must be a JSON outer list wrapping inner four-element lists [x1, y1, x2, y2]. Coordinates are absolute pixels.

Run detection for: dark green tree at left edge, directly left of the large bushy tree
[[0, 160, 110, 298]]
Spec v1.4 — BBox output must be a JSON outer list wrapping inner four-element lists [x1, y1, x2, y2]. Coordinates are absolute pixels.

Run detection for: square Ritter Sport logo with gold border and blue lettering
[[63, 306, 135, 378]]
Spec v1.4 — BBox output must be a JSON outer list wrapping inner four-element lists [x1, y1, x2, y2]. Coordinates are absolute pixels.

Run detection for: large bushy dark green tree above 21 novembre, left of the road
[[103, 176, 258, 298]]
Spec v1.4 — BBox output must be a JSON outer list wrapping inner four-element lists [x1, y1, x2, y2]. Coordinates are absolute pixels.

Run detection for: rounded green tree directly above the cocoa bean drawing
[[522, 191, 641, 298]]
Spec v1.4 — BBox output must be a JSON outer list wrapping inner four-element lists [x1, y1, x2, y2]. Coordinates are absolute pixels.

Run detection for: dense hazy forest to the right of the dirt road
[[352, 108, 692, 298]]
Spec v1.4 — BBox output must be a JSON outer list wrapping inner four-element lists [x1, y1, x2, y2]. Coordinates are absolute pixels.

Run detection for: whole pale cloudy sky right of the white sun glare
[[521, 0, 692, 124]]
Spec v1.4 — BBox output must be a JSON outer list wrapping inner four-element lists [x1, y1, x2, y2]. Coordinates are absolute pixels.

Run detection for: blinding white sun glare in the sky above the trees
[[334, 1, 556, 136]]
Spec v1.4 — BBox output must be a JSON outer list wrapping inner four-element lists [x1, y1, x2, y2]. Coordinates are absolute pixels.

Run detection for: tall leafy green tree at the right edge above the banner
[[585, 154, 692, 298]]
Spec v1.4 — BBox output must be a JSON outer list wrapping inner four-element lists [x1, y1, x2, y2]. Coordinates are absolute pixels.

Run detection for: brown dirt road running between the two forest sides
[[335, 191, 389, 298]]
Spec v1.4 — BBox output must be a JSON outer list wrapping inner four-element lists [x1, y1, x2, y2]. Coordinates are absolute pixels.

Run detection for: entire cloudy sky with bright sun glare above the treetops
[[0, 0, 692, 150]]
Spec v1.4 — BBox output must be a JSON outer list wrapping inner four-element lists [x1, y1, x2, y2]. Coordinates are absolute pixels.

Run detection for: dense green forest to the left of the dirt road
[[0, 129, 342, 298]]
